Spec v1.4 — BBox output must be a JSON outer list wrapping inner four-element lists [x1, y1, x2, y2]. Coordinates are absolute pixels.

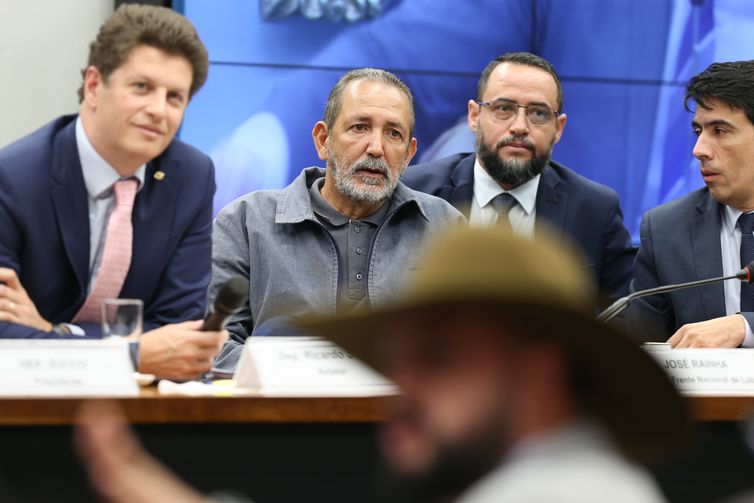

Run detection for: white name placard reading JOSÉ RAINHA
[[649, 348, 754, 395]]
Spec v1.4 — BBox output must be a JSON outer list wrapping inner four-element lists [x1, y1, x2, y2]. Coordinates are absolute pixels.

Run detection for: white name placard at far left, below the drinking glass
[[0, 340, 139, 396]]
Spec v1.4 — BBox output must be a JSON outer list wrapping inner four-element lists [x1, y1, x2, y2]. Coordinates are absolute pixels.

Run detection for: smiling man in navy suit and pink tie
[[0, 5, 227, 379]]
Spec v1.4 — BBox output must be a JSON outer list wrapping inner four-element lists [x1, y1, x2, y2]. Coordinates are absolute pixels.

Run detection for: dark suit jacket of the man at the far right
[[629, 188, 754, 340]]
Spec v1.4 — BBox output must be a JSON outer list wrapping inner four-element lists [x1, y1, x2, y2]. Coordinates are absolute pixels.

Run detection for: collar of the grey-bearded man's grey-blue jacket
[[275, 167, 429, 224]]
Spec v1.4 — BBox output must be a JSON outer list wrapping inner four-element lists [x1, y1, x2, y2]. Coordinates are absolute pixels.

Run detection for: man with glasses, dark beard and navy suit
[[403, 52, 635, 306]]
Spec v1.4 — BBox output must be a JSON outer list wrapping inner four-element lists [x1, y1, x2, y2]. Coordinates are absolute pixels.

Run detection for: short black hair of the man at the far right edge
[[683, 61, 754, 124]]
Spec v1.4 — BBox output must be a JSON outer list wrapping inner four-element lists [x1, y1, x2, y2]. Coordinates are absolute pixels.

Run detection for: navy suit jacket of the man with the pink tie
[[0, 115, 215, 338]]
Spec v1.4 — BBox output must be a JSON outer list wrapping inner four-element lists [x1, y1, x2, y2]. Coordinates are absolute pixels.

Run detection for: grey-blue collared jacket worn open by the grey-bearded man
[[208, 168, 463, 370]]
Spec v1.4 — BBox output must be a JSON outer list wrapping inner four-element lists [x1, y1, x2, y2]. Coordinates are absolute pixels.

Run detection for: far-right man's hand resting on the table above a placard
[[668, 314, 746, 349]]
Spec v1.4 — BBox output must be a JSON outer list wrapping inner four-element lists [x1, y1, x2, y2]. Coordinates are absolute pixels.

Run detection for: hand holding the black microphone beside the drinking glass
[[139, 321, 228, 381]]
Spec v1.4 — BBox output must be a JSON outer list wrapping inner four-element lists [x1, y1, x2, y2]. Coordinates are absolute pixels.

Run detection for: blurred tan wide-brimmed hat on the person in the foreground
[[296, 227, 688, 462]]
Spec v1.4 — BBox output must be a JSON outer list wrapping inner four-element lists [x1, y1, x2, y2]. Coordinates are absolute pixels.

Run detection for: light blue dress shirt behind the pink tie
[[76, 117, 146, 292]]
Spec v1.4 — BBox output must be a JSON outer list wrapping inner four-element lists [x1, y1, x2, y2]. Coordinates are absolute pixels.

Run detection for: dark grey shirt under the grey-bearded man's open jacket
[[309, 178, 394, 311]]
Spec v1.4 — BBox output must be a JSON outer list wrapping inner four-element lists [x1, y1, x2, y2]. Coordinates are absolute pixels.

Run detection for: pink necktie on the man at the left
[[73, 178, 139, 323]]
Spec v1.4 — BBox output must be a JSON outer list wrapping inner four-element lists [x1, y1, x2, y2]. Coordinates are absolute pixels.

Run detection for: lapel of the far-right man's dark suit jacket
[[690, 192, 725, 319]]
